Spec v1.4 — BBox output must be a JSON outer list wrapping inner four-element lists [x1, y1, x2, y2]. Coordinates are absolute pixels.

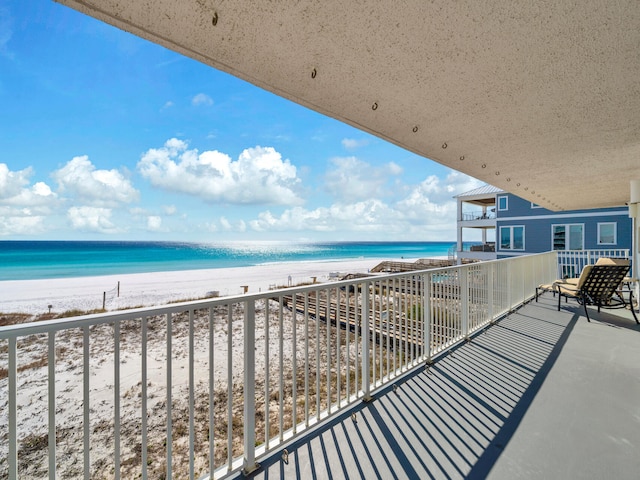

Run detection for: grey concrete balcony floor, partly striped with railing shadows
[[239, 293, 640, 480]]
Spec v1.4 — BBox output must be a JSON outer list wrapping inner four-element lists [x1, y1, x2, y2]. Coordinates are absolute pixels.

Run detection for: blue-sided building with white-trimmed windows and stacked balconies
[[456, 185, 632, 260]]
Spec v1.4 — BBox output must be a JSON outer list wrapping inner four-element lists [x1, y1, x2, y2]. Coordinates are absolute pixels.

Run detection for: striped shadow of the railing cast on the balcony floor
[[240, 301, 581, 479]]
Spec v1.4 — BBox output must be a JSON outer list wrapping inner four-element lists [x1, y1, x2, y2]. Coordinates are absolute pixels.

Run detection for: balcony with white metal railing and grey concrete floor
[[0, 252, 640, 478]]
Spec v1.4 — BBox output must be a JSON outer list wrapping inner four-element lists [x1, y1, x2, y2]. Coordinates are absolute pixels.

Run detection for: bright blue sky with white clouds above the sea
[[0, 0, 481, 241]]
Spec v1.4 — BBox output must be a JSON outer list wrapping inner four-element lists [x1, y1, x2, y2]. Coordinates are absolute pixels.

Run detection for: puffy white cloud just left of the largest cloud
[[51, 155, 139, 207]]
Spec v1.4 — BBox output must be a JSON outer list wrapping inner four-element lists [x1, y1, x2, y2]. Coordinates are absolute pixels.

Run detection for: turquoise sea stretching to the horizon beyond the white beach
[[0, 241, 454, 281]]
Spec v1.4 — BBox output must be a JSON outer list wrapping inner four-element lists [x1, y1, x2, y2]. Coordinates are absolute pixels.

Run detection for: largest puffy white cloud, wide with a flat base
[[138, 138, 302, 205]]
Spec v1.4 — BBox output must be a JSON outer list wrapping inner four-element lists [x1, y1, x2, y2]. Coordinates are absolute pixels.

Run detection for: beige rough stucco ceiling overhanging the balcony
[[59, 0, 640, 210]]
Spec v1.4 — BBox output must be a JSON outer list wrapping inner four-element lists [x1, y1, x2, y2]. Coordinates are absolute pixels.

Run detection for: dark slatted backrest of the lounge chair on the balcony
[[578, 258, 631, 304]]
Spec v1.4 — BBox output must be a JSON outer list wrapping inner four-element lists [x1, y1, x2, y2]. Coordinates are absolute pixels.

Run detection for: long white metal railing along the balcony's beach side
[[0, 252, 558, 479]]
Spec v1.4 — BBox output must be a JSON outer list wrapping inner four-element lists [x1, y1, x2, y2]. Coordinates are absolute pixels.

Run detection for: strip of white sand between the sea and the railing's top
[[0, 258, 400, 314]]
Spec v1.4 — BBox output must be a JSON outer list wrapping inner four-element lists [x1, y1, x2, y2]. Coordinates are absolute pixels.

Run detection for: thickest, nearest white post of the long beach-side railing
[[242, 300, 258, 475]]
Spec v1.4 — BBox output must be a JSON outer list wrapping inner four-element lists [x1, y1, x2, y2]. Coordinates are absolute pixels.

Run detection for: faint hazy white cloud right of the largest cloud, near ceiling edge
[[325, 157, 402, 202]]
